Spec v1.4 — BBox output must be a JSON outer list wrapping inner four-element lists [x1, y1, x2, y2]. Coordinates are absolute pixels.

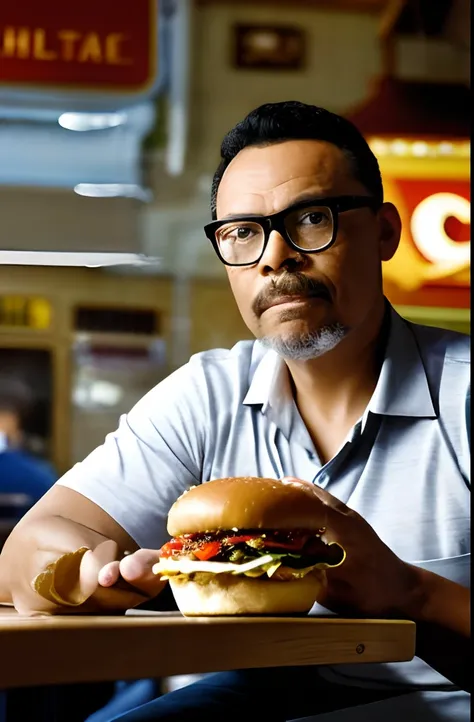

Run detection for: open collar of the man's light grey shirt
[[243, 306, 437, 428]]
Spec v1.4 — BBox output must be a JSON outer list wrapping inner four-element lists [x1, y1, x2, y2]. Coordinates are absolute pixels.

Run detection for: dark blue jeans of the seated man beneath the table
[[107, 668, 402, 722]]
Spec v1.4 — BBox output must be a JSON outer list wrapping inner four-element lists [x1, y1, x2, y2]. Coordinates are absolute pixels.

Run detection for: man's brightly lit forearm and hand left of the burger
[[0, 484, 170, 615]]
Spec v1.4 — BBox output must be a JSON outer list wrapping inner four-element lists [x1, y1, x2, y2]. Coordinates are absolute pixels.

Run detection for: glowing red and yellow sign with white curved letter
[[384, 178, 471, 308]]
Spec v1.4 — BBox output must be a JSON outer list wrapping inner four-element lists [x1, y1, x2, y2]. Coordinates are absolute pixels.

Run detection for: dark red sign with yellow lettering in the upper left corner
[[0, 0, 157, 92]]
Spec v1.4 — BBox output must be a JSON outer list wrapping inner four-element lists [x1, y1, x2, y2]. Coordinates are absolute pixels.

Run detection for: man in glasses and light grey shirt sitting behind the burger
[[0, 102, 470, 722]]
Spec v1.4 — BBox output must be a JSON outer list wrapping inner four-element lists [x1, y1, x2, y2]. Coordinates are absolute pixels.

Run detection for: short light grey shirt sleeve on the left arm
[[57, 358, 208, 549]]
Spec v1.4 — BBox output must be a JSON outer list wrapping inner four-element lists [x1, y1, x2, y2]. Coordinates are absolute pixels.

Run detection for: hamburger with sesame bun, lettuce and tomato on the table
[[153, 477, 345, 616]]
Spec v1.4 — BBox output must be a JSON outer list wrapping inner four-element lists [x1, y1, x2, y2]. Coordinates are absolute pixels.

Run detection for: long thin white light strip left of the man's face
[[0, 251, 161, 268]]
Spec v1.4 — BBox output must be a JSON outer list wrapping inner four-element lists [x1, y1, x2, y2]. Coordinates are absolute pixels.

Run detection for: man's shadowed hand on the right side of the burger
[[282, 477, 418, 617]]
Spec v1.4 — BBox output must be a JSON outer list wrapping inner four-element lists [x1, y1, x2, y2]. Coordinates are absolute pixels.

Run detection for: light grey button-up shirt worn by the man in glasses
[[58, 309, 470, 716]]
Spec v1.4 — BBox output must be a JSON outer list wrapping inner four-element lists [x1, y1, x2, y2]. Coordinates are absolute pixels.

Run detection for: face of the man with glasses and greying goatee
[[217, 140, 400, 358]]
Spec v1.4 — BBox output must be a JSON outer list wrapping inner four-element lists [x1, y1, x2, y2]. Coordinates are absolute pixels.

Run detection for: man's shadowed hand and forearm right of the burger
[[282, 477, 472, 693]]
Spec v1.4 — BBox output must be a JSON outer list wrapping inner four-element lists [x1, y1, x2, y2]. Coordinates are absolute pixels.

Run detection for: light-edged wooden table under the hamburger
[[0, 607, 415, 689]]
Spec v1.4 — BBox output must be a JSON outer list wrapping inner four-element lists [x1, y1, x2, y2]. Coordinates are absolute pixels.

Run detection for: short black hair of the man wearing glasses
[[211, 100, 383, 219]]
